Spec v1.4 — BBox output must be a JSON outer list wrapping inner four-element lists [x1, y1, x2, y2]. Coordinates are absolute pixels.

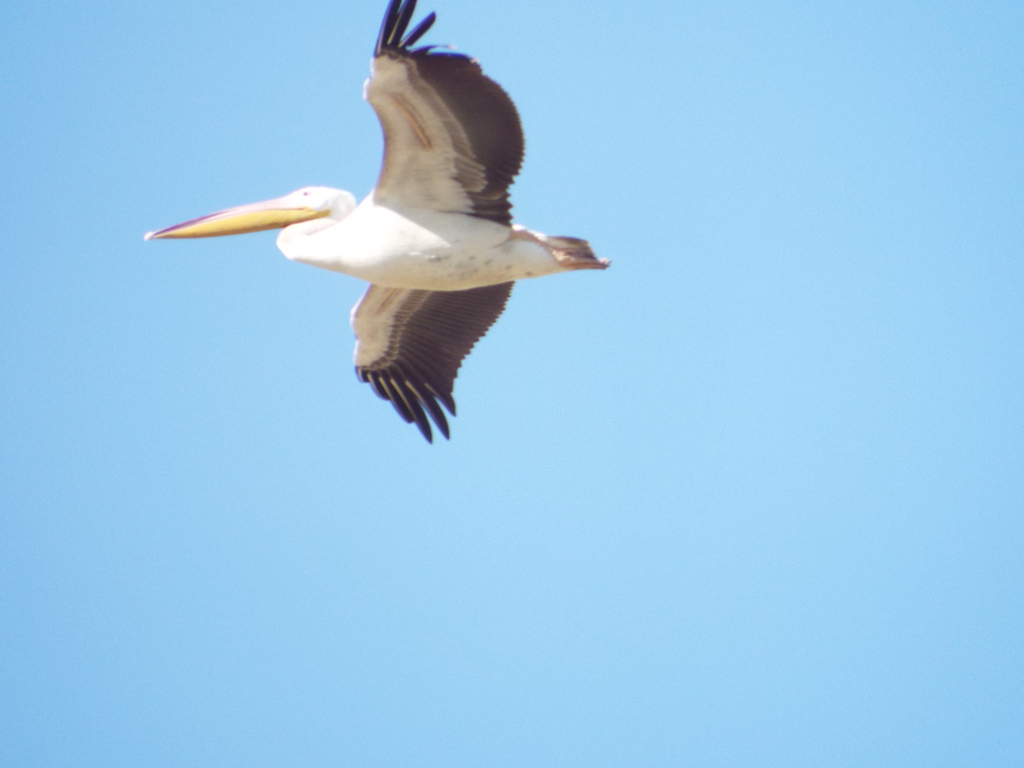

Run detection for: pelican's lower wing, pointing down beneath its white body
[[352, 283, 512, 442]]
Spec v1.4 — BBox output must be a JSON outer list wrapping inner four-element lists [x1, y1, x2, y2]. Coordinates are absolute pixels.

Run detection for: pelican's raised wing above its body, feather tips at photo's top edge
[[365, 0, 523, 224]]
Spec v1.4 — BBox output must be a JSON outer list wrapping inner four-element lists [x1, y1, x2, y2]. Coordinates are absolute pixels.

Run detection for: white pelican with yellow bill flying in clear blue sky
[[145, 0, 609, 442]]
